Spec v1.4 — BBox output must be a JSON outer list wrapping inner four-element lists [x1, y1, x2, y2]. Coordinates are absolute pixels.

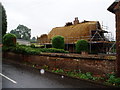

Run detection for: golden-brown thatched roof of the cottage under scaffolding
[[48, 21, 101, 43]]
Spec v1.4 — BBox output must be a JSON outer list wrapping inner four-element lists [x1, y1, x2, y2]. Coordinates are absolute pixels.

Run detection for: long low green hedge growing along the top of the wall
[[2, 45, 68, 55]]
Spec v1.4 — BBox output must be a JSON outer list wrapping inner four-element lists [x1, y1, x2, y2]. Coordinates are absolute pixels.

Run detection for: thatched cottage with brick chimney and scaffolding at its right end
[[37, 17, 108, 51]]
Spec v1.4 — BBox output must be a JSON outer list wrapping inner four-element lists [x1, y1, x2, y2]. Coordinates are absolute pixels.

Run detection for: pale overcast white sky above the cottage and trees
[[0, 0, 116, 38]]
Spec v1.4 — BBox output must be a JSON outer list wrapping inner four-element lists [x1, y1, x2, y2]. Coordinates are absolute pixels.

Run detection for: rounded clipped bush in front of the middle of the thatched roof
[[52, 36, 65, 49]]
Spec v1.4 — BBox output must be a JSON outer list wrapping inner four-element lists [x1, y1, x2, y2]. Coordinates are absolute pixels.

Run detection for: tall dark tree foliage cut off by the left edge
[[0, 3, 7, 37]]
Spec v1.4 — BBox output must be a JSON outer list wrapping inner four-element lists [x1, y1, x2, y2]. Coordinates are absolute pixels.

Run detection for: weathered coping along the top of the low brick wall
[[40, 53, 116, 61]]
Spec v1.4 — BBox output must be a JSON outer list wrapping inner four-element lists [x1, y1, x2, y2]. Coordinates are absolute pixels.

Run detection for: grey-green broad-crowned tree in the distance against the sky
[[10, 25, 31, 40]]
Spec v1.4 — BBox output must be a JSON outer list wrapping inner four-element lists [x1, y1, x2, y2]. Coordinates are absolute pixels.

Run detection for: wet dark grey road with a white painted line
[[2, 62, 110, 88]]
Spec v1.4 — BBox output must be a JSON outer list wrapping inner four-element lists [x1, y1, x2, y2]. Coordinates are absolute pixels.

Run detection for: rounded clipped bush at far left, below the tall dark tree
[[3, 33, 16, 47]]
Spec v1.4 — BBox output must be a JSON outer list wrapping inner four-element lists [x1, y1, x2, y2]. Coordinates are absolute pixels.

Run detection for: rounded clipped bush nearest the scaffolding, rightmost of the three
[[75, 39, 88, 53]]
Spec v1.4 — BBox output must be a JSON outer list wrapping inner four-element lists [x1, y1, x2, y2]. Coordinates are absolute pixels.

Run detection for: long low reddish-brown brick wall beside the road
[[3, 52, 115, 75]]
